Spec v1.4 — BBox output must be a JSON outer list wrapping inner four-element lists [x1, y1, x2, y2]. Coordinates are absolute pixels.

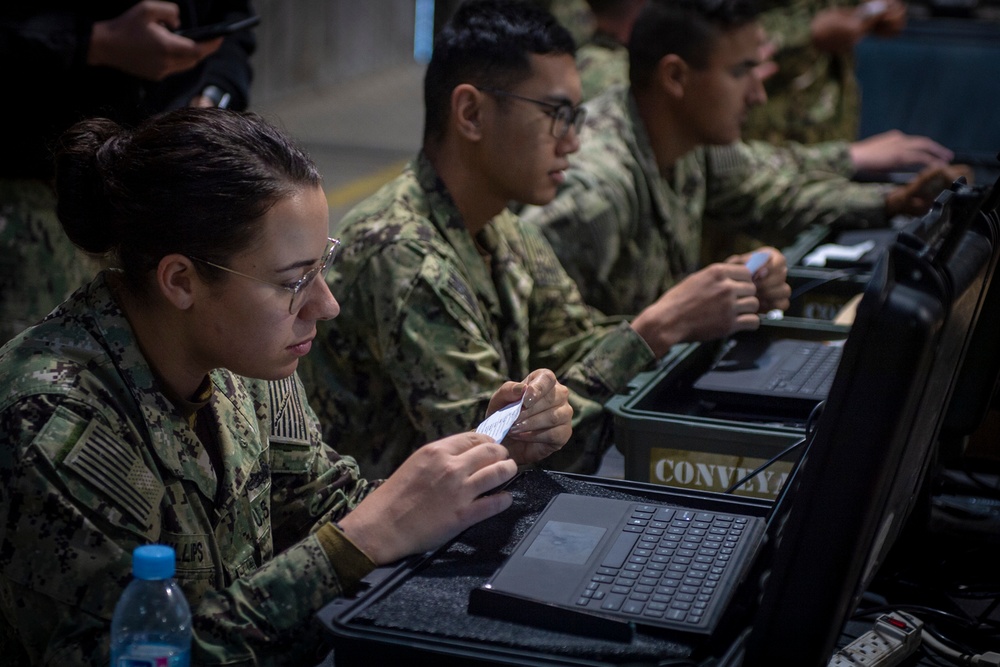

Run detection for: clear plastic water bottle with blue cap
[[111, 544, 191, 667]]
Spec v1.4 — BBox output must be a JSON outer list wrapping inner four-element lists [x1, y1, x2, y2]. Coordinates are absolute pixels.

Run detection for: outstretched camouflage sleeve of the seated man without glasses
[[706, 144, 887, 247]]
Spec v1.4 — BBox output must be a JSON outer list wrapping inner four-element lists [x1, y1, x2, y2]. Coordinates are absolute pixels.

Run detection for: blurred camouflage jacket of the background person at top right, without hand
[[743, 0, 860, 143]]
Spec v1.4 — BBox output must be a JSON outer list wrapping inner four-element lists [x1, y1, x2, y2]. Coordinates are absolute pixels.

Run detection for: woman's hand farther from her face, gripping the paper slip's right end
[[486, 368, 573, 465]]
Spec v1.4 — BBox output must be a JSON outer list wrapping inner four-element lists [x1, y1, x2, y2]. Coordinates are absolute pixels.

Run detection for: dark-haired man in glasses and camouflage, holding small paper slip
[[299, 0, 772, 474]]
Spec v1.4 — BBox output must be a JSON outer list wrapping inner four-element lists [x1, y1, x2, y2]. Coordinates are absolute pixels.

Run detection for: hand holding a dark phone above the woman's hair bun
[[87, 0, 223, 81]]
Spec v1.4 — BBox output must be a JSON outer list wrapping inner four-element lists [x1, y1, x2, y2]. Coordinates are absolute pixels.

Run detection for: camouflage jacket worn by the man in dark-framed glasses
[[300, 155, 653, 476]]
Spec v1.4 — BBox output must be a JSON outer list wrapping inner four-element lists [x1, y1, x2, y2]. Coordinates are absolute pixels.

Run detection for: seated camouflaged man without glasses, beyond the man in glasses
[[521, 0, 964, 315]]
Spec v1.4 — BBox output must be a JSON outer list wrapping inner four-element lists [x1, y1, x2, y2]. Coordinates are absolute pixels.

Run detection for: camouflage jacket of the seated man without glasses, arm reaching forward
[[521, 87, 885, 315]]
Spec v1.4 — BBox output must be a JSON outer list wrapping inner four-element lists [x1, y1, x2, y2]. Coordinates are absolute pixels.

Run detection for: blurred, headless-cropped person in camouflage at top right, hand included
[[744, 0, 906, 143]]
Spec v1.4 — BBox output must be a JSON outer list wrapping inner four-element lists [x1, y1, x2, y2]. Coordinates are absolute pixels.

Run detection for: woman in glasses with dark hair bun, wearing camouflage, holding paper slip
[[0, 108, 571, 667]]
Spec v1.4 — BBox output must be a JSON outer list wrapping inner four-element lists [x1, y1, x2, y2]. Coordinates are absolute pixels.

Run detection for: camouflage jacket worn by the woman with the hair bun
[[0, 274, 373, 665]]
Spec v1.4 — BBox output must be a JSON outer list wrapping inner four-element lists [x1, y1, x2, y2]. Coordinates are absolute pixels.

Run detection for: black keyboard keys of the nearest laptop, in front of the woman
[[576, 505, 756, 631]]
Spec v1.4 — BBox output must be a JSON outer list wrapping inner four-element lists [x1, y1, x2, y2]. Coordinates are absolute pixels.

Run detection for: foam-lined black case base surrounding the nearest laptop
[[317, 471, 771, 667]]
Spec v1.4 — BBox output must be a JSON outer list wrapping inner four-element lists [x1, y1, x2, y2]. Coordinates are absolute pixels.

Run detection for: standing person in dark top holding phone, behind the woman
[[0, 0, 255, 343]]
